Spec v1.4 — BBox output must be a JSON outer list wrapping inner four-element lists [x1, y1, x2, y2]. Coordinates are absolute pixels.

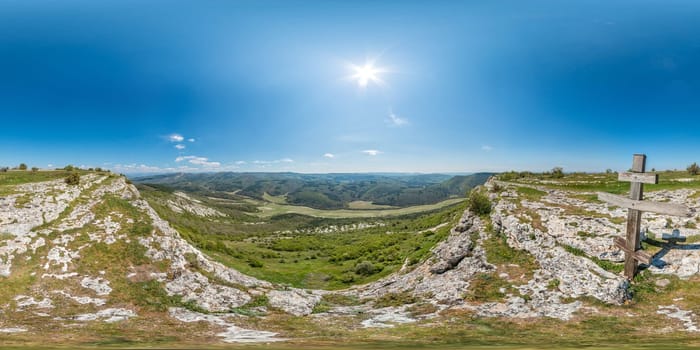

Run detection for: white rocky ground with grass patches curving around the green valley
[[0, 173, 700, 343]]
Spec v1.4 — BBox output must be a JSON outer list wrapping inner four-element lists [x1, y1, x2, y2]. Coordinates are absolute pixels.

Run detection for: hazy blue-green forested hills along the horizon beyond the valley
[[133, 172, 493, 209]]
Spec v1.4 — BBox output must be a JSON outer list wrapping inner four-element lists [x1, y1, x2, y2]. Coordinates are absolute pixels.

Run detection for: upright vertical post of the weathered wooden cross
[[625, 154, 647, 279]]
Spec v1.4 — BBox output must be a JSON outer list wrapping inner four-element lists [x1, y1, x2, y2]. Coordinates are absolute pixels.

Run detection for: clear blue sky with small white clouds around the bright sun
[[0, 0, 700, 173]]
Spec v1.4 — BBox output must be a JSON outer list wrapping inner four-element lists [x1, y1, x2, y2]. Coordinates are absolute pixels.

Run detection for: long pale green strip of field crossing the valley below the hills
[[246, 198, 466, 219]]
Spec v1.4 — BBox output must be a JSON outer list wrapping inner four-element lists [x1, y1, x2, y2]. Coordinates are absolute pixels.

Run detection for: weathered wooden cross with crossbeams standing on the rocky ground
[[598, 154, 690, 280]]
